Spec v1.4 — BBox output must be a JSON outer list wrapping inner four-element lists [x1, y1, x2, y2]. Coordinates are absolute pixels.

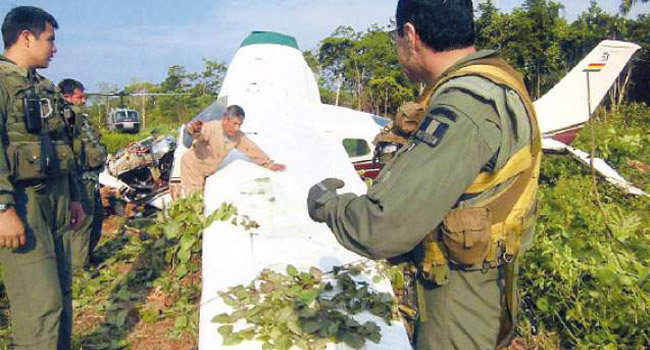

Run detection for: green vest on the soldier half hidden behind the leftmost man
[[72, 107, 108, 172]]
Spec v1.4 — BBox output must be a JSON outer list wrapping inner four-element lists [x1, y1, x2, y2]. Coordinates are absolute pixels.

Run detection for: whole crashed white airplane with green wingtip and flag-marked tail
[[98, 32, 643, 349]]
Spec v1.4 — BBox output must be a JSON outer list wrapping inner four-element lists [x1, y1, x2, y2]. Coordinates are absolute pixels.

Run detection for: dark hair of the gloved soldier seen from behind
[[395, 0, 476, 52]]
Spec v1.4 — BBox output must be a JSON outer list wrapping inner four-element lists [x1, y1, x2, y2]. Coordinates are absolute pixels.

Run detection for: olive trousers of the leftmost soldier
[[0, 177, 72, 350]]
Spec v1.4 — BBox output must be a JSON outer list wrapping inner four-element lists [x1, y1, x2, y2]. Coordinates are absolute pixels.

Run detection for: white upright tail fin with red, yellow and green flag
[[534, 40, 640, 135]]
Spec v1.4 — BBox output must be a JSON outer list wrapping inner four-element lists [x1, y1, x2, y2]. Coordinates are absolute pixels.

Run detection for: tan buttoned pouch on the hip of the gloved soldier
[[442, 208, 491, 266]]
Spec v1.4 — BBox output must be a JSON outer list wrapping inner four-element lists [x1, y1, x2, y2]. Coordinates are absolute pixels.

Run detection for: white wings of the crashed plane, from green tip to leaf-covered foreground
[[185, 32, 411, 349]]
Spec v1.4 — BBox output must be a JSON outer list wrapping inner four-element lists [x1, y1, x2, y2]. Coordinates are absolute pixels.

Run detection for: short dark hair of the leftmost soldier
[[2, 6, 59, 49]]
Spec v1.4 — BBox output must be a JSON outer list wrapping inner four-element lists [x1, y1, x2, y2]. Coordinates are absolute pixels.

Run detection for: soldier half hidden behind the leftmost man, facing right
[[59, 79, 108, 269]]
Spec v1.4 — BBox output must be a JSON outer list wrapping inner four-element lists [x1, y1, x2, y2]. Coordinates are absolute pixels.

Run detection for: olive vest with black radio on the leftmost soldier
[[0, 57, 75, 183]]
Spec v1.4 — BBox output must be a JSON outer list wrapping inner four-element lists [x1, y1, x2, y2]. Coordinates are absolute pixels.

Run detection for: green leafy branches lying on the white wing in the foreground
[[212, 265, 393, 349]]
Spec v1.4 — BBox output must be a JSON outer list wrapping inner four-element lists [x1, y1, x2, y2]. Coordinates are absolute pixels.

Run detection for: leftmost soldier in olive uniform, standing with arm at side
[[0, 6, 83, 350]]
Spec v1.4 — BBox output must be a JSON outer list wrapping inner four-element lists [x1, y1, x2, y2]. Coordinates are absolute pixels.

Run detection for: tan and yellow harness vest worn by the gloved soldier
[[416, 57, 542, 340]]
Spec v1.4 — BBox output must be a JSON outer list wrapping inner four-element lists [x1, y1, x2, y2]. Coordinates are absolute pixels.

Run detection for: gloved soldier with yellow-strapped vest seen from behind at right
[[307, 0, 541, 350]]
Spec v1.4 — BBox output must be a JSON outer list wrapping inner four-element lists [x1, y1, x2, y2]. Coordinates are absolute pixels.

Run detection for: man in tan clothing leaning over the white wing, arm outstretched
[[181, 105, 286, 196]]
